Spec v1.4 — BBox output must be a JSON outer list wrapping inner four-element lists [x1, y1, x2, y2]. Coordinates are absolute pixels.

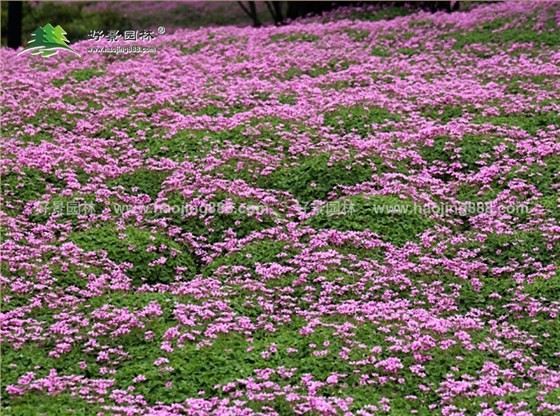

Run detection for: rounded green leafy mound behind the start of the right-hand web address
[[307, 195, 433, 245]]
